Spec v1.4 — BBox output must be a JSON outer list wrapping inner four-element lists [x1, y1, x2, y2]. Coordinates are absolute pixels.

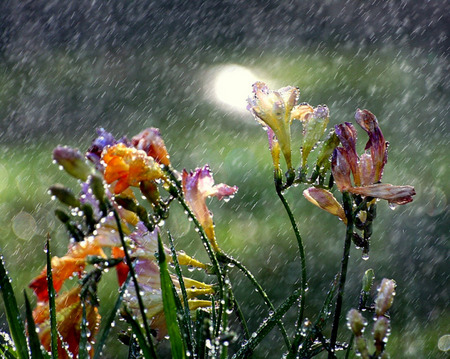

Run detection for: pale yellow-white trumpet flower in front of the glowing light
[[248, 82, 300, 169]]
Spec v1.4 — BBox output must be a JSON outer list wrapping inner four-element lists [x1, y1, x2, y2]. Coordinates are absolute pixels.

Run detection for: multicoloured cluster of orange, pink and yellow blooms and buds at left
[[30, 128, 237, 358]]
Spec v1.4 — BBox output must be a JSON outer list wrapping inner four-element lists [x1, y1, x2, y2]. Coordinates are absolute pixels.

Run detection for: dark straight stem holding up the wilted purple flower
[[328, 192, 353, 359]]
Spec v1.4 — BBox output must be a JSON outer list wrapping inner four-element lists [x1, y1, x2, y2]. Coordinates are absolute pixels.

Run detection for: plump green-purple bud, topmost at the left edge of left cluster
[[53, 146, 91, 181]]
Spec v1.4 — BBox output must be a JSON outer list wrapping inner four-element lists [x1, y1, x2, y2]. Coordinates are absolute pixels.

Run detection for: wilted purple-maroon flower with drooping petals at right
[[331, 110, 416, 204]]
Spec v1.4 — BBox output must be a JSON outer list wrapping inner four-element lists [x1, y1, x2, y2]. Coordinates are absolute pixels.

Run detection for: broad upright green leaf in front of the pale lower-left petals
[[158, 234, 186, 359]]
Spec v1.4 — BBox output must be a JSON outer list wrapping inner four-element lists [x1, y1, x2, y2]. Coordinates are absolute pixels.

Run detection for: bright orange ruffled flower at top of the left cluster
[[102, 143, 164, 194]]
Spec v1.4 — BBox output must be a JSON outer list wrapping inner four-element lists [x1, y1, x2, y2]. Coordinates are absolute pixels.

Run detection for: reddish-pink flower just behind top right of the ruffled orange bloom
[[131, 127, 170, 166]]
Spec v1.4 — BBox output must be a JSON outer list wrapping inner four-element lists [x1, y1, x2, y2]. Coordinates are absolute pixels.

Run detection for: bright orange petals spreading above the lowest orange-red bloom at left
[[29, 241, 105, 301]]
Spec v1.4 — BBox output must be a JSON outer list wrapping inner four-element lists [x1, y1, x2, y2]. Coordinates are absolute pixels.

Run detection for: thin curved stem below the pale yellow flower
[[275, 185, 306, 354]]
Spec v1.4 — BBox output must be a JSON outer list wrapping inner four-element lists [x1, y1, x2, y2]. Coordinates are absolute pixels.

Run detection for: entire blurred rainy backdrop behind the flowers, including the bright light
[[0, 1, 450, 358]]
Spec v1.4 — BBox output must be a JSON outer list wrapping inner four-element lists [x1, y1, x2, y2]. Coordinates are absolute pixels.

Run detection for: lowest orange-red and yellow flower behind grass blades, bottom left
[[33, 287, 100, 359]]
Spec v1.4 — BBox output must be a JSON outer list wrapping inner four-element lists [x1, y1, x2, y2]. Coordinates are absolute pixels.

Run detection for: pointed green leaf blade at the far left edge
[[0, 256, 28, 359]]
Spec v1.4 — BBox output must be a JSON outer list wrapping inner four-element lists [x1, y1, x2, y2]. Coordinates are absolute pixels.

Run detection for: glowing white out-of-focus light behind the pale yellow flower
[[214, 65, 258, 112]]
